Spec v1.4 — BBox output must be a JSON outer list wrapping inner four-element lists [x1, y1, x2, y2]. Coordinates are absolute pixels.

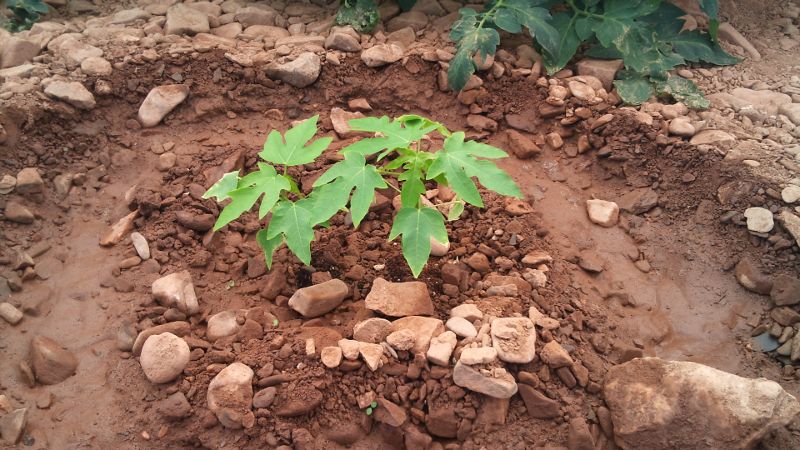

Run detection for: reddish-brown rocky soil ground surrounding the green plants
[[0, 0, 800, 450]]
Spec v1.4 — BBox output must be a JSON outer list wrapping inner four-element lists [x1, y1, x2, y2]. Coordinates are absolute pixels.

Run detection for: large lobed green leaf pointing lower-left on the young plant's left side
[[206, 163, 290, 231]]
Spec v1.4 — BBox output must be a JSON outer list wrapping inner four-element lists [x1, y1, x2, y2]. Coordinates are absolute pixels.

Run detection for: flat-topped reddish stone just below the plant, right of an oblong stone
[[365, 277, 433, 317]]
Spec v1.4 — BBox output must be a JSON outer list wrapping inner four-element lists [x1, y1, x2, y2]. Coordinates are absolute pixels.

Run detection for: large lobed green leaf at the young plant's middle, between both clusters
[[314, 153, 388, 228]]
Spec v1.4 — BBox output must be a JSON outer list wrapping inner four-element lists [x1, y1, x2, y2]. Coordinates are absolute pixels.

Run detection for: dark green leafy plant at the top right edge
[[448, 0, 738, 108]]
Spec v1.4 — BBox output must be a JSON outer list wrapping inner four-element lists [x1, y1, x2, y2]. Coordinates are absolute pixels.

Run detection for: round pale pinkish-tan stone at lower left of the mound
[[139, 333, 190, 384]]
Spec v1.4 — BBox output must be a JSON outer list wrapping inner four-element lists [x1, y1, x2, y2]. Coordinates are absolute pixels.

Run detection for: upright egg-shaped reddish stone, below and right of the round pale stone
[[206, 362, 254, 429]]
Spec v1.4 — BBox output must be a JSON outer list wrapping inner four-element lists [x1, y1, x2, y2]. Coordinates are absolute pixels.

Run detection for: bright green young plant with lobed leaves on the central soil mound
[[204, 115, 522, 277]]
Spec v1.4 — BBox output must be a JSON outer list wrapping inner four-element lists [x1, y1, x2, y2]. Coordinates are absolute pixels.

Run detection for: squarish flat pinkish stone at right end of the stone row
[[491, 317, 536, 364]]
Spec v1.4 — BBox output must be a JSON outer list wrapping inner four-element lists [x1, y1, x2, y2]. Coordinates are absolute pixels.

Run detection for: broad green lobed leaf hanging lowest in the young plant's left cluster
[[265, 199, 317, 265]]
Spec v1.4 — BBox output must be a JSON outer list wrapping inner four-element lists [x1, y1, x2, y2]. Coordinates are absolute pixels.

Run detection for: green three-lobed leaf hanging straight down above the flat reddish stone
[[389, 206, 448, 278]]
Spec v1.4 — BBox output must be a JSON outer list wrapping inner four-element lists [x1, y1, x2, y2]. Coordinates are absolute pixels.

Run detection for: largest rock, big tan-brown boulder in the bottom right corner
[[604, 358, 800, 450]]
